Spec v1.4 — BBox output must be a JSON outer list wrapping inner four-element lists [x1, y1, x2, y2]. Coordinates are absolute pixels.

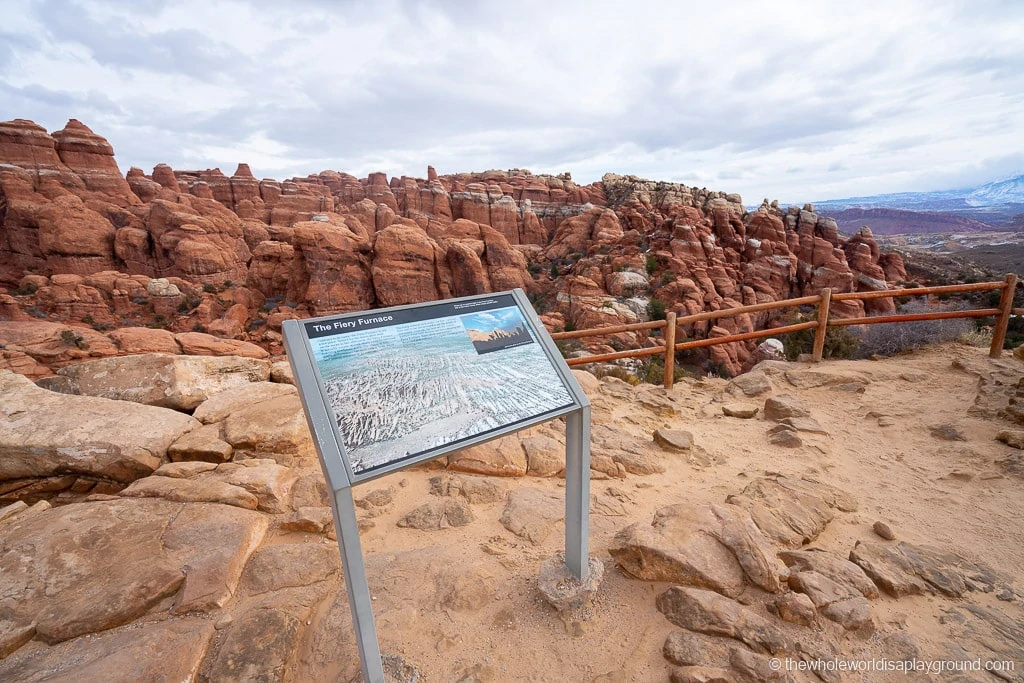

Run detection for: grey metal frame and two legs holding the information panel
[[282, 288, 591, 683]]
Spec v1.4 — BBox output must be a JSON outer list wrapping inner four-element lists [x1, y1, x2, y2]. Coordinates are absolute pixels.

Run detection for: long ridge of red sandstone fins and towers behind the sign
[[0, 120, 906, 372]]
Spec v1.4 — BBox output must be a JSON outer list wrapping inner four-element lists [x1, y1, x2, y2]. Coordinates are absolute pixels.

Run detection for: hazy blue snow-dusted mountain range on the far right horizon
[[814, 174, 1024, 225]]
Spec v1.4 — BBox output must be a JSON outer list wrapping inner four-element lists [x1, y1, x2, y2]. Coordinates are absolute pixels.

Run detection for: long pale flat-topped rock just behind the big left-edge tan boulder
[[39, 353, 270, 411]]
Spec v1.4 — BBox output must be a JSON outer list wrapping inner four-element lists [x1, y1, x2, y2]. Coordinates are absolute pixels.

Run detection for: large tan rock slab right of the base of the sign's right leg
[[608, 504, 781, 596]]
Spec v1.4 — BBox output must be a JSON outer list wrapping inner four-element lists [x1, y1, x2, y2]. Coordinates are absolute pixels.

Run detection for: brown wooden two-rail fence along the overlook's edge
[[551, 273, 1024, 389]]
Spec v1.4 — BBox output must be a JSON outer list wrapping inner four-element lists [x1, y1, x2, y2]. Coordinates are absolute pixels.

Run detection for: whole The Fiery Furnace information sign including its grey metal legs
[[282, 289, 590, 683]]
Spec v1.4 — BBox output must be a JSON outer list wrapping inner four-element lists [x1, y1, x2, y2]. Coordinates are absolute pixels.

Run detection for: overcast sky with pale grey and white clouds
[[0, 0, 1024, 204]]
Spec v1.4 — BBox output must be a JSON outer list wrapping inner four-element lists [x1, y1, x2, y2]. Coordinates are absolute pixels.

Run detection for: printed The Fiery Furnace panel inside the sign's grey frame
[[305, 294, 574, 474]]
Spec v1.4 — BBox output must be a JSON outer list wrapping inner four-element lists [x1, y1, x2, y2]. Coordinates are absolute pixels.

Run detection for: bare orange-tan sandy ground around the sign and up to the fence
[[280, 345, 1024, 681]]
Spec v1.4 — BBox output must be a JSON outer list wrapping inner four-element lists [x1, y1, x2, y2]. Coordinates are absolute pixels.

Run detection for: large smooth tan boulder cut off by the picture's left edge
[[0, 371, 200, 481]]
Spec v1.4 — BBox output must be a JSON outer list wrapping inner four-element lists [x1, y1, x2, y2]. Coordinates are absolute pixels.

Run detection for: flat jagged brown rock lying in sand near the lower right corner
[[850, 541, 1009, 598]]
